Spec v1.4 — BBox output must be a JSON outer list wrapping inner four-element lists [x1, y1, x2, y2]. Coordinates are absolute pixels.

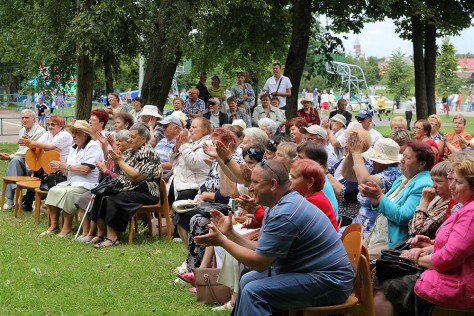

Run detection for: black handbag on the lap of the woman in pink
[[375, 250, 425, 282]]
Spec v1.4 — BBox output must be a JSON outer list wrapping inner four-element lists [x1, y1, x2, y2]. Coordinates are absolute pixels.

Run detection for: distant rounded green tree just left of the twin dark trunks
[[384, 51, 413, 97]]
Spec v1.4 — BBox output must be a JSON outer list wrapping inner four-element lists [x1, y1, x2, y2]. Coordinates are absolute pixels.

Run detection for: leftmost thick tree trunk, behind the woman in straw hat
[[76, 52, 94, 120]]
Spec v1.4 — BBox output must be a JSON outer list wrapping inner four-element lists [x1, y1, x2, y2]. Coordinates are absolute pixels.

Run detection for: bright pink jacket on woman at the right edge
[[415, 201, 474, 308]]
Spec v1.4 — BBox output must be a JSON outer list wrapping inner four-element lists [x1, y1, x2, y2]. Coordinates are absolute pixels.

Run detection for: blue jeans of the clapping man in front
[[234, 270, 353, 316]]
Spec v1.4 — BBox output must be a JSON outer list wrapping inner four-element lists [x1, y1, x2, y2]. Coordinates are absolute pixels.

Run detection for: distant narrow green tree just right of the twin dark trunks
[[436, 37, 462, 95]]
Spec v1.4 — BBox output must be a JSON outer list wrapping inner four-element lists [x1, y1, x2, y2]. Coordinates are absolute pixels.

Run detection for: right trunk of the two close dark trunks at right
[[425, 24, 437, 115]]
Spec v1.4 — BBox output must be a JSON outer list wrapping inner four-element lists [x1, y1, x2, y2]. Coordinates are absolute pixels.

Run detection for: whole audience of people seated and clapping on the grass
[[1, 82, 474, 315]]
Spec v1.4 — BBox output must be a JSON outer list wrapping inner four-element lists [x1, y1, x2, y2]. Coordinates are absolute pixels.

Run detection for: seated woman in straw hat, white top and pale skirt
[[40, 120, 104, 237]]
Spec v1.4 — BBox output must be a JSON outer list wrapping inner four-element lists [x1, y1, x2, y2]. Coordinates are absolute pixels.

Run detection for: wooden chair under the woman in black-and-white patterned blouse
[[128, 179, 171, 245]]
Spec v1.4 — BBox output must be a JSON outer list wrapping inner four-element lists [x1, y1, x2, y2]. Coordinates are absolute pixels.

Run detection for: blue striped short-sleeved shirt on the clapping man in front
[[256, 191, 353, 284]]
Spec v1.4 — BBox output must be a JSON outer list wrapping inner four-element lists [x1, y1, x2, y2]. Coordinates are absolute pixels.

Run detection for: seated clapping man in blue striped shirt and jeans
[[195, 160, 354, 316]]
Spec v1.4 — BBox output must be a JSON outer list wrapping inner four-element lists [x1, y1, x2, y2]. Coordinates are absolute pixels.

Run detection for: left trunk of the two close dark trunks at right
[[411, 16, 428, 119]]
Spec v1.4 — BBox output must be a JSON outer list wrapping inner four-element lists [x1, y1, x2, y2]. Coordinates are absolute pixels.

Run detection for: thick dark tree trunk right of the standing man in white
[[284, 0, 313, 120]]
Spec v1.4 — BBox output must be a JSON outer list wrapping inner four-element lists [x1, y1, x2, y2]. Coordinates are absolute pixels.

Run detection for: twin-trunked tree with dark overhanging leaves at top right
[[364, 0, 474, 118]]
